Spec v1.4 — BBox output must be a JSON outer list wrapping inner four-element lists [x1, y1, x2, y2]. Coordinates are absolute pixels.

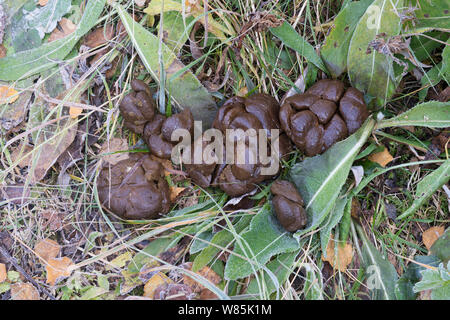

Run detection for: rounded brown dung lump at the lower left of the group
[[97, 153, 170, 220]]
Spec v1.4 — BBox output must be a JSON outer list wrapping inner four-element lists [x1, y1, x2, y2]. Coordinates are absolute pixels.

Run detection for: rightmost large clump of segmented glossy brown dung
[[279, 79, 369, 156]]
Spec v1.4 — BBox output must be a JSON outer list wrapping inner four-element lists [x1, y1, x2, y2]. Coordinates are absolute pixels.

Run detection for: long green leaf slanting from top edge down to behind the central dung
[[115, 5, 217, 127]]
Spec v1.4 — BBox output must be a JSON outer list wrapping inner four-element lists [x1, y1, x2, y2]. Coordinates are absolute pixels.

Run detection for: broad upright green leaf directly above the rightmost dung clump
[[347, 0, 403, 104]]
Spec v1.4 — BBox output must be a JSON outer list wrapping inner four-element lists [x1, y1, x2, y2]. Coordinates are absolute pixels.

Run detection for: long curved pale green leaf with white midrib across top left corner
[[0, 0, 106, 81]]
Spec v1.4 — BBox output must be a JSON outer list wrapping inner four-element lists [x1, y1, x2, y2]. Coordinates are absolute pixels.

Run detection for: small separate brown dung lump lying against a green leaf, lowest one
[[270, 180, 307, 232]]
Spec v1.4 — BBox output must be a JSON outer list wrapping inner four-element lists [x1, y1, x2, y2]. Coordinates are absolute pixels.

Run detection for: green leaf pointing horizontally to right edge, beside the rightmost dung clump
[[377, 101, 450, 129]]
